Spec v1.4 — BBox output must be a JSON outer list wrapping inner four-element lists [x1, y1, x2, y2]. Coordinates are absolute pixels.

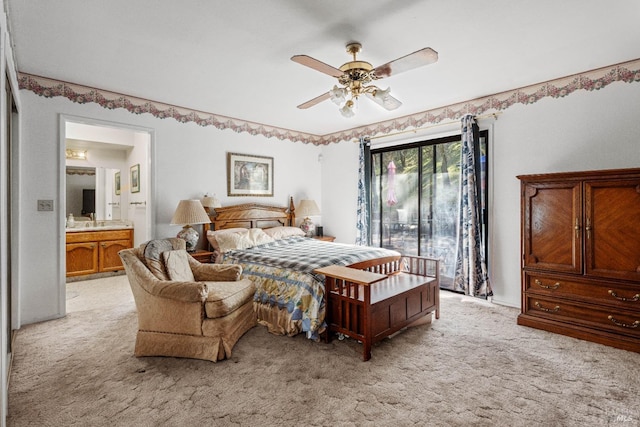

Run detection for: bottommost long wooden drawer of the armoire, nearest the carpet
[[523, 295, 640, 338]]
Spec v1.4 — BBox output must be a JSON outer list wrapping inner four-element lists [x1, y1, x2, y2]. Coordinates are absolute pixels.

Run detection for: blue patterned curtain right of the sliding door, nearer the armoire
[[453, 114, 493, 298]]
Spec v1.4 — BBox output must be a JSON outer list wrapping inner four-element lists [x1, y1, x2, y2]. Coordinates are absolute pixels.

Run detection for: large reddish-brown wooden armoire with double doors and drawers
[[518, 169, 640, 352]]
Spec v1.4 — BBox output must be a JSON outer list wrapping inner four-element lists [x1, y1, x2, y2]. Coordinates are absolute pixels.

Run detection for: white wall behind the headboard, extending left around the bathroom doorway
[[19, 90, 321, 324]]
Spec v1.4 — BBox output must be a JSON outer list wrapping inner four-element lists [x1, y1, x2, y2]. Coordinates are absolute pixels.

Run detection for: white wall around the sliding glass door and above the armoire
[[322, 82, 640, 307]]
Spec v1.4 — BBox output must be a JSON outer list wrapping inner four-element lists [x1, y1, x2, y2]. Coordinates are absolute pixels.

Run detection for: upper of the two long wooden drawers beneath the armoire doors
[[524, 271, 640, 312]]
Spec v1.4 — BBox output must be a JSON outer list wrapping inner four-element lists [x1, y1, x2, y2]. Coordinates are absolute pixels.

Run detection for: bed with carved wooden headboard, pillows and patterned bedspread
[[205, 199, 401, 340]]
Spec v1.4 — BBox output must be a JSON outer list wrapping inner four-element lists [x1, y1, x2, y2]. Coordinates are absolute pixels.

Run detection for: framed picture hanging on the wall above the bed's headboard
[[227, 153, 273, 196]]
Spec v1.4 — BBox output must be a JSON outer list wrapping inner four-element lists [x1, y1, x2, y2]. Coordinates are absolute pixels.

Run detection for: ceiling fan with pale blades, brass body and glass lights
[[291, 42, 438, 117]]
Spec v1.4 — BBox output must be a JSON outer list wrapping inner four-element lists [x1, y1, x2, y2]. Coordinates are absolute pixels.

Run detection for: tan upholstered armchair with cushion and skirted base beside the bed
[[119, 238, 256, 362]]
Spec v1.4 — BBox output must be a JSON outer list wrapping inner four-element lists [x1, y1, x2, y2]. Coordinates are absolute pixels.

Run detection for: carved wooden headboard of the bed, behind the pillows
[[204, 197, 296, 234]]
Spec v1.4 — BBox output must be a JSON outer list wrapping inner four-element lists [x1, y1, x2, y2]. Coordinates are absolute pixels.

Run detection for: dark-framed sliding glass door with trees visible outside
[[370, 131, 487, 288]]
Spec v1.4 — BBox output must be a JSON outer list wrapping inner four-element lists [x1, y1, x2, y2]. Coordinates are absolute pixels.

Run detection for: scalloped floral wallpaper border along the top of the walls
[[18, 59, 640, 145]]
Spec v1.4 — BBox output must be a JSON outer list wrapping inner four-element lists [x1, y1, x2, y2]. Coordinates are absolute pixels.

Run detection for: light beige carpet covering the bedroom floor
[[7, 276, 640, 427]]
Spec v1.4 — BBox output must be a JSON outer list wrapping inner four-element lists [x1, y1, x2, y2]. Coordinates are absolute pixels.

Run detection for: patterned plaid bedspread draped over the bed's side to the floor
[[222, 237, 400, 339]]
